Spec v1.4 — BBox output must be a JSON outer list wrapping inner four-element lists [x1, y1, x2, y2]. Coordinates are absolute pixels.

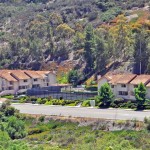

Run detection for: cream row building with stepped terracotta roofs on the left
[[0, 70, 56, 95]]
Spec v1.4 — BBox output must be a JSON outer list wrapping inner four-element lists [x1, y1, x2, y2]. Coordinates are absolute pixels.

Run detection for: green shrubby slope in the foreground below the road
[[0, 102, 150, 150]]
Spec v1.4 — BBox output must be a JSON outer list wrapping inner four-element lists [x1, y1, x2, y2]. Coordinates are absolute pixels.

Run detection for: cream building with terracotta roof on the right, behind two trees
[[98, 73, 150, 100]]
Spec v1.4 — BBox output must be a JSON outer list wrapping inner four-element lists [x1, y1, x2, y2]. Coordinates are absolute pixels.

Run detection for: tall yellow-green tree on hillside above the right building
[[109, 15, 133, 61]]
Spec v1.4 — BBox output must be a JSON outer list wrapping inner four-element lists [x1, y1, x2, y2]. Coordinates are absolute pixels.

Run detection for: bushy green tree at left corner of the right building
[[99, 83, 114, 106]]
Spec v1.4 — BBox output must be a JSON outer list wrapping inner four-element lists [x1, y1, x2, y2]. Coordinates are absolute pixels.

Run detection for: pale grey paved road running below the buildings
[[12, 104, 150, 121]]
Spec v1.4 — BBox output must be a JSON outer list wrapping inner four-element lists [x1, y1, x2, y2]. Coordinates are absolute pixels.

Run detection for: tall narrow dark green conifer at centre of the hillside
[[84, 25, 96, 72]]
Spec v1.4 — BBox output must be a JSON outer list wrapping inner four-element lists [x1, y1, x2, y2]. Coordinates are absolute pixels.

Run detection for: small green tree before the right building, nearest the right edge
[[134, 83, 146, 108]]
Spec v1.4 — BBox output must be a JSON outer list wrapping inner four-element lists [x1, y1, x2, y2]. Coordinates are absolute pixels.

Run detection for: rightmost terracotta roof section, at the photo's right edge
[[130, 75, 150, 85]]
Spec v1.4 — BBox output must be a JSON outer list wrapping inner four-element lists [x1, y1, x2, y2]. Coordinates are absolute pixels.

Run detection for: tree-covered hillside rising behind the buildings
[[0, 0, 150, 82]]
